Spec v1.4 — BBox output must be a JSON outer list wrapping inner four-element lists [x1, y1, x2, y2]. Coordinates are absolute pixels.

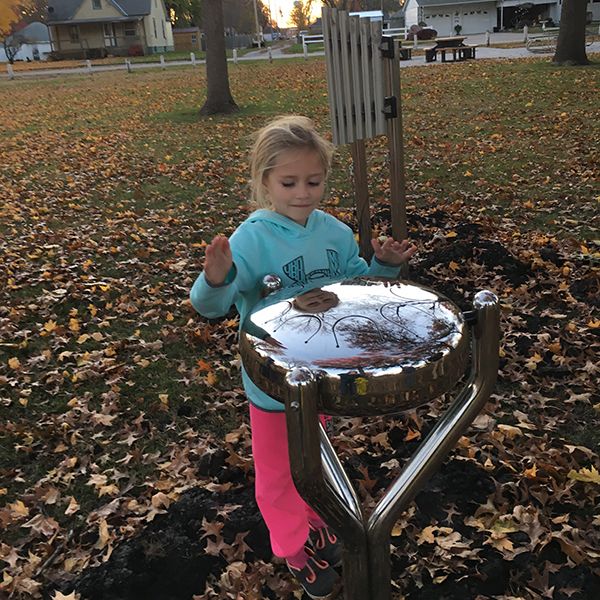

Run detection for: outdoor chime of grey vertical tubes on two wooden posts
[[322, 7, 407, 258]]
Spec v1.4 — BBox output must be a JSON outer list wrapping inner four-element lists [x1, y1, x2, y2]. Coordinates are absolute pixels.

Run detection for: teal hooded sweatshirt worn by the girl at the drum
[[190, 209, 400, 412]]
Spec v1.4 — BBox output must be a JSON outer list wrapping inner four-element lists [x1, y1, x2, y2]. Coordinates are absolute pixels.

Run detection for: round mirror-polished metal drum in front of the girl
[[240, 277, 470, 416]]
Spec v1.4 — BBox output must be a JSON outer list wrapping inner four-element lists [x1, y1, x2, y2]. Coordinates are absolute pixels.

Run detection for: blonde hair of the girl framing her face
[[250, 115, 333, 208]]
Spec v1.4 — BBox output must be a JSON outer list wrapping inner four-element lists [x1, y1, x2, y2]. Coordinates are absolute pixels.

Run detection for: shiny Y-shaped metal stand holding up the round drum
[[285, 291, 500, 600]]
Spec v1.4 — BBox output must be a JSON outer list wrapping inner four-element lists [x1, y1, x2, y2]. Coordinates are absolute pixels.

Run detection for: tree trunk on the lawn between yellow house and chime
[[200, 0, 238, 115]]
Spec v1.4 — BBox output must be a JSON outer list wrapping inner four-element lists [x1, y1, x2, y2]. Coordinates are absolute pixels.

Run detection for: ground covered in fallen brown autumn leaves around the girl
[[0, 60, 600, 600]]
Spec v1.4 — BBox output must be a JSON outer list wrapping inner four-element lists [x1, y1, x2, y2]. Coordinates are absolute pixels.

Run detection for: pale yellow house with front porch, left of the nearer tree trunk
[[48, 0, 174, 58]]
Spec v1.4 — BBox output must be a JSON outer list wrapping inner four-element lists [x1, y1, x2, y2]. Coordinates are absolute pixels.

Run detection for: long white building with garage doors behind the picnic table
[[404, 0, 600, 36]]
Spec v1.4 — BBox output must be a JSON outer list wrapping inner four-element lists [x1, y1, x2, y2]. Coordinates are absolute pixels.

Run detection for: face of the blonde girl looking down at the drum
[[263, 149, 325, 226]]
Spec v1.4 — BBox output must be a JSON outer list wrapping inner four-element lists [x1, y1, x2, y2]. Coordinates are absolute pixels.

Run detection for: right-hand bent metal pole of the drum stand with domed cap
[[367, 291, 500, 600]]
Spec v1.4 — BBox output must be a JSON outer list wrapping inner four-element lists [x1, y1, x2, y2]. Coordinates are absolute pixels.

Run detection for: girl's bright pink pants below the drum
[[250, 404, 324, 558]]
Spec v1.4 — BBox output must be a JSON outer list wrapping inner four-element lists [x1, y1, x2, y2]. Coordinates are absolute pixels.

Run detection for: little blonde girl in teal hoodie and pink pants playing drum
[[191, 116, 416, 599]]
